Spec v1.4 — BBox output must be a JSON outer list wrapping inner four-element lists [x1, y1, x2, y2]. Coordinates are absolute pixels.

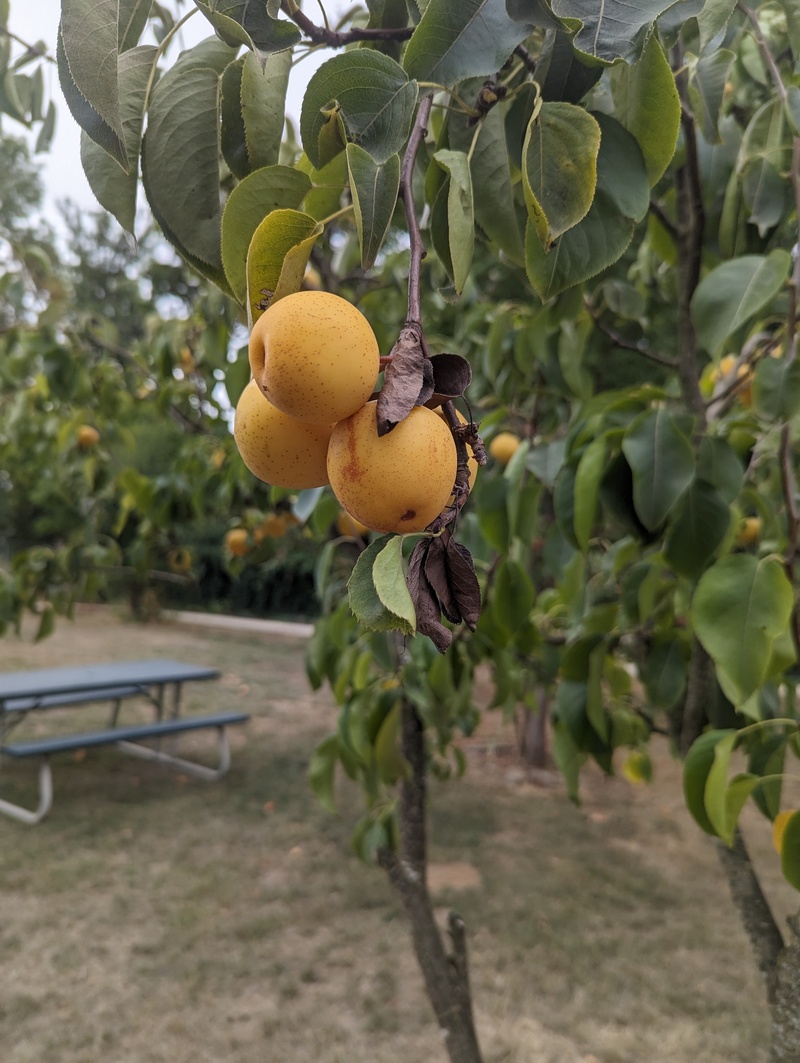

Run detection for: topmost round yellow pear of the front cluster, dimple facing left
[[250, 291, 380, 427]]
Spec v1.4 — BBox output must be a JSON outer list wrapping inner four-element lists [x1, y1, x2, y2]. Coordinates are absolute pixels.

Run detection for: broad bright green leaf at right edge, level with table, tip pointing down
[[692, 554, 794, 707]]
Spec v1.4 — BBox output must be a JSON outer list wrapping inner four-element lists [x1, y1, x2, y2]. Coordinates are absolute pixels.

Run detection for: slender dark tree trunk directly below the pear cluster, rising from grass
[[379, 702, 482, 1063]]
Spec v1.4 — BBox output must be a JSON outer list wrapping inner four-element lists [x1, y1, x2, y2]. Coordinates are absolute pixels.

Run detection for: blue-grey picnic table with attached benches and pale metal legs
[[0, 658, 249, 824]]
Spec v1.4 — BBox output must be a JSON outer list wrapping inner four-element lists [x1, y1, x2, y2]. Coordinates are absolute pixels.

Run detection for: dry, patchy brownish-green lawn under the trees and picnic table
[[0, 612, 794, 1063]]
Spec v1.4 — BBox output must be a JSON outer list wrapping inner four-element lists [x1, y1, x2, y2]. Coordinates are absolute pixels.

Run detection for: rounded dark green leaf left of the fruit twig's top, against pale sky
[[300, 48, 419, 169]]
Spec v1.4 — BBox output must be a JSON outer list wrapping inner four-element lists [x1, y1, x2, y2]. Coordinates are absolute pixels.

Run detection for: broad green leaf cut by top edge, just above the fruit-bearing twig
[[403, 0, 530, 85]]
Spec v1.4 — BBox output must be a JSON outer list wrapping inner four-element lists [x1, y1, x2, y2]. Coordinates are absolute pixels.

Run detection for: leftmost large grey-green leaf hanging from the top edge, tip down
[[56, 0, 129, 169]]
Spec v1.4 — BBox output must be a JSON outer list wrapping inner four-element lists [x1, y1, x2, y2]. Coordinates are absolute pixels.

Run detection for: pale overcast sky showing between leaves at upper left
[[3, 0, 345, 223]]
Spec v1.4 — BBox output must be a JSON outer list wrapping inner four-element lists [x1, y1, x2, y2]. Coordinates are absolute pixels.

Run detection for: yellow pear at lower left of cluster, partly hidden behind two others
[[234, 381, 334, 490]]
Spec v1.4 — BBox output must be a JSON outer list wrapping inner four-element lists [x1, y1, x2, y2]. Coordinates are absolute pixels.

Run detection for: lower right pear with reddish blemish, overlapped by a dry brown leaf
[[327, 402, 457, 534]]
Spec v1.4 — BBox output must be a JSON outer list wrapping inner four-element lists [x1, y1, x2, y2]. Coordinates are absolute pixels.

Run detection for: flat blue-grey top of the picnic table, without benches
[[0, 658, 220, 702]]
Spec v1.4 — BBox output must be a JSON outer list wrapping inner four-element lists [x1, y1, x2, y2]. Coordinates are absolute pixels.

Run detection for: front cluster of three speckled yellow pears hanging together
[[234, 291, 457, 533]]
